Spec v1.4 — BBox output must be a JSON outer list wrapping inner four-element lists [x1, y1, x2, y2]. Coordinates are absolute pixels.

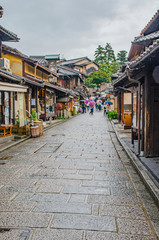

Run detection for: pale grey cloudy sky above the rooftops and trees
[[0, 0, 159, 59]]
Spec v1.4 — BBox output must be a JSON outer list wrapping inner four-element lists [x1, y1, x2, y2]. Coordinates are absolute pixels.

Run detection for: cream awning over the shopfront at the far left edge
[[0, 82, 28, 92]]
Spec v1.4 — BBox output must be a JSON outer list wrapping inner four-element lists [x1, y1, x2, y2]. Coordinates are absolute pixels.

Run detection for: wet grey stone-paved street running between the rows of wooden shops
[[0, 112, 159, 240]]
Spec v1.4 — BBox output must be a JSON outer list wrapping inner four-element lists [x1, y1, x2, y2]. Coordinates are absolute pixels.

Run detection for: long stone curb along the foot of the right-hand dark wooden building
[[111, 121, 159, 205]]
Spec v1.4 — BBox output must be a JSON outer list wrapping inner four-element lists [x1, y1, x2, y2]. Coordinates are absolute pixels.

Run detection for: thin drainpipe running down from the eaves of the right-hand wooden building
[[126, 66, 143, 156]]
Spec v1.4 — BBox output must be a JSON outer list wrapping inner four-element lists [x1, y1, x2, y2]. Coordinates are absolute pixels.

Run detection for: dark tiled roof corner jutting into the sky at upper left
[[0, 25, 19, 42]]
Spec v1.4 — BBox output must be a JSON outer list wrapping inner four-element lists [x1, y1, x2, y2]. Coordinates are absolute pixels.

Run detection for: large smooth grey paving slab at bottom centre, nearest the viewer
[[51, 214, 117, 232]]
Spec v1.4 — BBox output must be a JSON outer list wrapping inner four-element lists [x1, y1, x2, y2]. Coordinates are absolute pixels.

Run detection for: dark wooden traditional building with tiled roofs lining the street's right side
[[112, 11, 159, 157]]
